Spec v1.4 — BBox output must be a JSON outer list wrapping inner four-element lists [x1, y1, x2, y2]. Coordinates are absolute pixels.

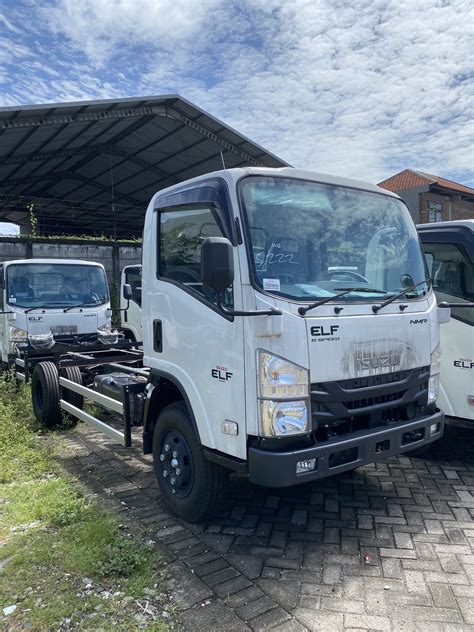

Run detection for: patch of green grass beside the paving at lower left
[[0, 375, 173, 632]]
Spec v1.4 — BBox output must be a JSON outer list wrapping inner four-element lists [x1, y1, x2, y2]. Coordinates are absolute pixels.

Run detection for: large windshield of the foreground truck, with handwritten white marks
[[240, 176, 428, 301]]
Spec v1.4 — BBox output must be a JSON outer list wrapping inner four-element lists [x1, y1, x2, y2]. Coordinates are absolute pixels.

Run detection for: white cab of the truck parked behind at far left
[[0, 259, 111, 379]]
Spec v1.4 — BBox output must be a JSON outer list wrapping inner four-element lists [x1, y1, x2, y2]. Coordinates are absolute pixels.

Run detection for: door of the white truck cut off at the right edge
[[421, 235, 474, 420]]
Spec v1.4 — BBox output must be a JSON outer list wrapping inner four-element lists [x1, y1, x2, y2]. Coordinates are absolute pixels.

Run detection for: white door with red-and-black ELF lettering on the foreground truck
[[143, 203, 246, 458]]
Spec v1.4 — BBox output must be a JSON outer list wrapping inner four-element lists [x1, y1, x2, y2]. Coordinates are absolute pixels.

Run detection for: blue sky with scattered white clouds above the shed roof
[[0, 0, 474, 186]]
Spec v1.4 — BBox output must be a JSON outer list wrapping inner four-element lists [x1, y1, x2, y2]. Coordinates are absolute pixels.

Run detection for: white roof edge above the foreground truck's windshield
[[152, 167, 400, 202]]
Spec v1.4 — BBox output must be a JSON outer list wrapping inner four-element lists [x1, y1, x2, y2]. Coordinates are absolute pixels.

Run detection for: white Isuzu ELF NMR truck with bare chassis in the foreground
[[30, 168, 449, 521]]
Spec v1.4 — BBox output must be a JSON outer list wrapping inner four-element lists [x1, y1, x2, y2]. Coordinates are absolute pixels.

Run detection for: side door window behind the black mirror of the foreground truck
[[159, 206, 233, 307]]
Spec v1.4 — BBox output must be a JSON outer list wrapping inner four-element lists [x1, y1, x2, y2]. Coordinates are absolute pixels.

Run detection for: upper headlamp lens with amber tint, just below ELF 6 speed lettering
[[258, 351, 309, 399]]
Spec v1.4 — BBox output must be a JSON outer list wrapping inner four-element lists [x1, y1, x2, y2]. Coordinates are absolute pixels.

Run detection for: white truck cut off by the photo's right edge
[[418, 220, 474, 428]]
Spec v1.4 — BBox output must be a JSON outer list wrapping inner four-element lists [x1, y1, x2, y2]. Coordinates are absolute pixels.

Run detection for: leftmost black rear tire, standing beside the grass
[[31, 362, 61, 428]]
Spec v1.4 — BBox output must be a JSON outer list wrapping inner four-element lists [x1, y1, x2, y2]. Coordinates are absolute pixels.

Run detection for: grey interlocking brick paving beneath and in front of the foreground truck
[[58, 425, 474, 632]]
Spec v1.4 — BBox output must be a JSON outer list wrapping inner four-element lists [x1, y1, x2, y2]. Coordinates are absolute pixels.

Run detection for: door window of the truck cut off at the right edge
[[423, 243, 474, 325]]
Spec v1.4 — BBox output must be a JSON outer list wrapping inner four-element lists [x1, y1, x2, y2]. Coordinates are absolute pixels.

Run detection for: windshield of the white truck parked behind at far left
[[6, 263, 109, 308]]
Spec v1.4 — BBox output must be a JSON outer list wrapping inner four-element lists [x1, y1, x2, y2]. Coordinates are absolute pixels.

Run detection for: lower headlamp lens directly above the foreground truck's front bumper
[[260, 399, 309, 437]]
